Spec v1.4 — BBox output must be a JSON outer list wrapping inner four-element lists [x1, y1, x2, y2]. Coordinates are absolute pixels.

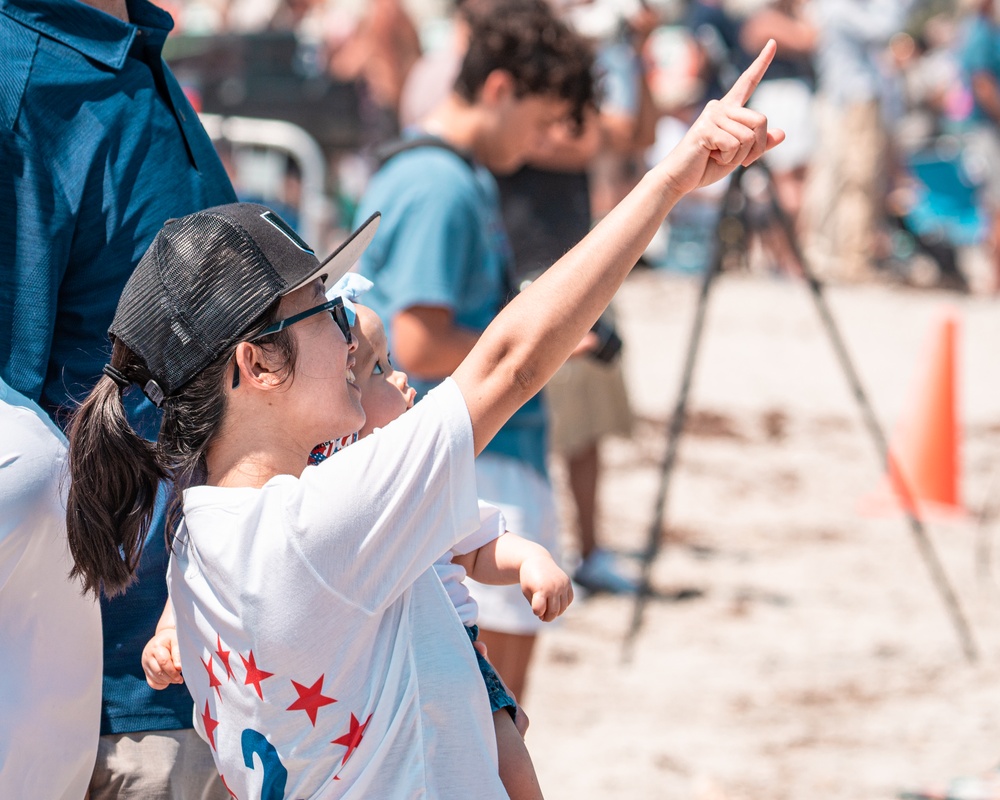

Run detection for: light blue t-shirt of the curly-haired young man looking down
[[357, 146, 546, 475]]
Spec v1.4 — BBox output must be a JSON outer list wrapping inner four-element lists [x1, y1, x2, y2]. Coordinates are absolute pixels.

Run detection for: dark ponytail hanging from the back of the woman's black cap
[[66, 343, 166, 597]]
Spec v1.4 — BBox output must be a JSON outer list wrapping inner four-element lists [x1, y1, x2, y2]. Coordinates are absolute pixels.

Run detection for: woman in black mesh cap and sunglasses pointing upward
[[67, 43, 783, 798]]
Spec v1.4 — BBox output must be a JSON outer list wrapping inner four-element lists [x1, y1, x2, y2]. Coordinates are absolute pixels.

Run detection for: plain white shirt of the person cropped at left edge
[[0, 380, 102, 800]]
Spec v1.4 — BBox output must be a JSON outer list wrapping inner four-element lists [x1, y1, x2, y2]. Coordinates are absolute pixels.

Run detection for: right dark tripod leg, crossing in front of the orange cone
[[757, 162, 978, 662]]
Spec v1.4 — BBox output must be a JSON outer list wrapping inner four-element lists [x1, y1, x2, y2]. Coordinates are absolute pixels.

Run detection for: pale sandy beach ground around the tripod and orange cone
[[523, 271, 1000, 800]]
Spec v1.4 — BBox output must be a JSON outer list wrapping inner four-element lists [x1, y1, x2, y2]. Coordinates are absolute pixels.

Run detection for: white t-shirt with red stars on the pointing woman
[[168, 380, 507, 800]]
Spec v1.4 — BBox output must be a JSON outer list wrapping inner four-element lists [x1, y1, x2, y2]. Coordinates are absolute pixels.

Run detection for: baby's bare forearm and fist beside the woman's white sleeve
[[454, 532, 573, 622]]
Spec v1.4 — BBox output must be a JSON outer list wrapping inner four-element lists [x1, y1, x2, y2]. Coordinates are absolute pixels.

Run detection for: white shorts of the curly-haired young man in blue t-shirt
[[466, 453, 560, 635]]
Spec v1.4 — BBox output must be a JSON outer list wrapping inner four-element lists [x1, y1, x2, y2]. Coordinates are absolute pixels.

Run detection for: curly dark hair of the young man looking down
[[455, 0, 596, 127]]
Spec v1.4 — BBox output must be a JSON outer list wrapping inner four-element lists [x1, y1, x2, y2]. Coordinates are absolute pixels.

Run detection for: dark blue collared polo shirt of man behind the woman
[[0, 0, 236, 734]]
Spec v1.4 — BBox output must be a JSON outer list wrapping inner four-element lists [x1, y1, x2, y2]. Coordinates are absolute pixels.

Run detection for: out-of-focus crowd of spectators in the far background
[[158, 0, 1000, 291]]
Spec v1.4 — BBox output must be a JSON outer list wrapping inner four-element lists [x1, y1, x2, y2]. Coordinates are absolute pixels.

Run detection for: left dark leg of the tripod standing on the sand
[[622, 167, 745, 662]]
